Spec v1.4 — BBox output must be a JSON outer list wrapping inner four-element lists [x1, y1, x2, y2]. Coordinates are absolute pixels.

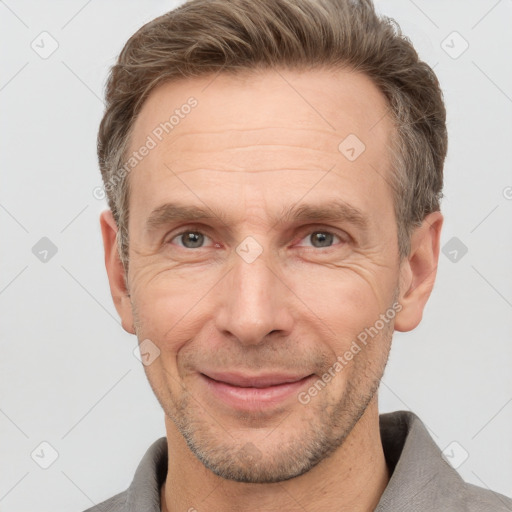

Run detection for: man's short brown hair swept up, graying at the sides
[[98, 0, 448, 268]]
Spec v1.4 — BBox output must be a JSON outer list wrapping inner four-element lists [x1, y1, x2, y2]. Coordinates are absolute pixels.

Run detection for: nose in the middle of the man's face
[[215, 250, 293, 345]]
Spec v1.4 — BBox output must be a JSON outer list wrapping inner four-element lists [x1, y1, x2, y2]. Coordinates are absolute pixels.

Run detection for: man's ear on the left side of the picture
[[100, 210, 135, 334]]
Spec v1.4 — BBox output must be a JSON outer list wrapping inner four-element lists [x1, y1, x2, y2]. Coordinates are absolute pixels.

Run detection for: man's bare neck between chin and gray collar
[[161, 397, 390, 512]]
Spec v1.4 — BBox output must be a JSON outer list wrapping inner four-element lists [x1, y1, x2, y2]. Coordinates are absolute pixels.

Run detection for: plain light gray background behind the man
[[0, 0, 512, 512]]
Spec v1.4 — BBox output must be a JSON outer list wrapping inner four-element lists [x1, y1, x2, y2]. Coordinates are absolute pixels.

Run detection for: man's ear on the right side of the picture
[[395, 212, 443, 332]]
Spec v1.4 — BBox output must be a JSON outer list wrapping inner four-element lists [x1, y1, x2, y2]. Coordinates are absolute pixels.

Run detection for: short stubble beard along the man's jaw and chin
[[136, 312, 394, 483]]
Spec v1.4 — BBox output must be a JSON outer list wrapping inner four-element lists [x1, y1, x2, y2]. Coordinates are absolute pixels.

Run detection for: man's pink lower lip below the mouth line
[[201, 374, 314, 410]]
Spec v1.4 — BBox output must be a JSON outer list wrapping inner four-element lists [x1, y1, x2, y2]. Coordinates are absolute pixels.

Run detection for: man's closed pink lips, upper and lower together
[[200, 372, 314, 411]]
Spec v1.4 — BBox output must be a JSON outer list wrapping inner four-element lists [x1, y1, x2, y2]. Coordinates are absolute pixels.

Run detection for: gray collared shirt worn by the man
[[85, 411, 512, 512]]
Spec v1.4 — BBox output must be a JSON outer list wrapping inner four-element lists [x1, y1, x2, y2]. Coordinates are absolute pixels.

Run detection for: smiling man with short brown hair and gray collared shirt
[[90, 0, 512, 512]]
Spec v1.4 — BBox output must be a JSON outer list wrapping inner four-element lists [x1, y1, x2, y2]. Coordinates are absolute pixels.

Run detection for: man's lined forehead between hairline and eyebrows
[[125, 70, 394, 226]]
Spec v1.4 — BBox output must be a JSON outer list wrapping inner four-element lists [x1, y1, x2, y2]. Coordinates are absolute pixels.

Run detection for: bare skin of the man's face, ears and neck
[[101, 70, 443, 512]]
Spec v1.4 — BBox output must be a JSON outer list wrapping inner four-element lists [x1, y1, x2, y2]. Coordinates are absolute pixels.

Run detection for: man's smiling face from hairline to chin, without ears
[[124, 71, 400, 482]]
